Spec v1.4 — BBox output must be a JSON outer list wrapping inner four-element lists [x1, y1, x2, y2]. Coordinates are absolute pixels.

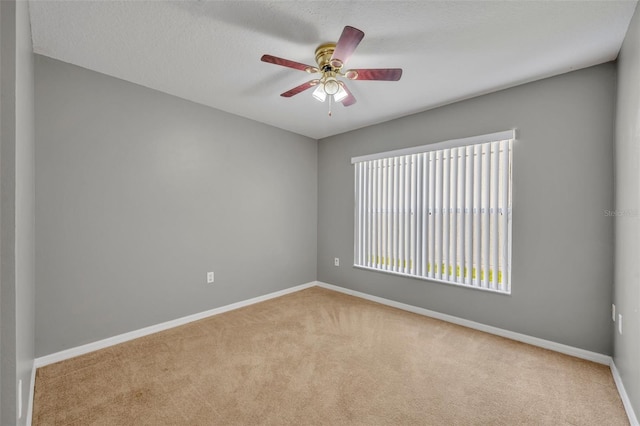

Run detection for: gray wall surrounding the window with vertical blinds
[[318, 63, 616, 354]]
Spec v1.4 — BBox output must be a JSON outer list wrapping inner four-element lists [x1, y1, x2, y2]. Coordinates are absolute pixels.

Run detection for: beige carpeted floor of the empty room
[[33, 287, 628, 426]]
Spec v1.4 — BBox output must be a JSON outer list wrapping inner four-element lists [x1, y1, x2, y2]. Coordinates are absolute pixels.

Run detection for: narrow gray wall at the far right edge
[[611, 1, 640, 415]]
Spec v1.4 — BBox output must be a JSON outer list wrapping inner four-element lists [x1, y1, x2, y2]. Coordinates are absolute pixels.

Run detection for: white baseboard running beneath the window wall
[[318, 282, 611, 365]]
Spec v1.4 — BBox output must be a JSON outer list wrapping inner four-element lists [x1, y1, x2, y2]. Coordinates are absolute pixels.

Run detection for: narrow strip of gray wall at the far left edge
[[0, 1, 35, 425]]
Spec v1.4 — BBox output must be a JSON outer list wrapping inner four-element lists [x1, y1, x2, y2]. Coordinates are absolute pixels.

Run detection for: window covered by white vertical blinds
[[351, 130, 515, 293]]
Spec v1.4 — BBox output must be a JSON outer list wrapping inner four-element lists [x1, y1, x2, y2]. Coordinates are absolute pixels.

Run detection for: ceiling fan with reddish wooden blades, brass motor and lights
[[260, 26, 402, 115]]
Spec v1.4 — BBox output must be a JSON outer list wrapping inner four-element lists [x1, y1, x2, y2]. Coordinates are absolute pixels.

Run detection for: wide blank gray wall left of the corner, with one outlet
[[35, 55, 317, 356]]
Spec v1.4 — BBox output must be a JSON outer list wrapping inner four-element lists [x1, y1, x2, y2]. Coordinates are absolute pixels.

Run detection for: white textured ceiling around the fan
[[29, 0, 636, 139]]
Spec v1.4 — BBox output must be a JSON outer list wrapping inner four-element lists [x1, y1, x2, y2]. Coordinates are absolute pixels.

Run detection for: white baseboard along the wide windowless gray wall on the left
[[34, 281, 318, 368]]
